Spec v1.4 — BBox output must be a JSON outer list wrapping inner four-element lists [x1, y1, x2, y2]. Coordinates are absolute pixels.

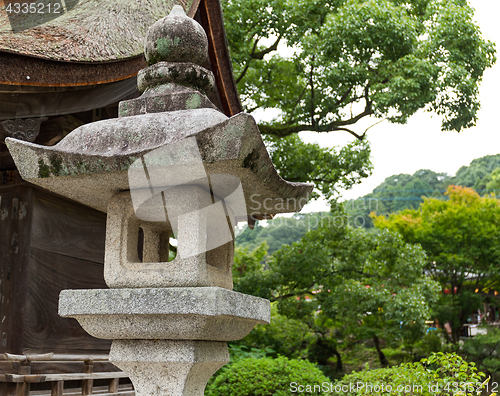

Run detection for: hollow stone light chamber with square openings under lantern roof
[[104, 186, 234, 289]]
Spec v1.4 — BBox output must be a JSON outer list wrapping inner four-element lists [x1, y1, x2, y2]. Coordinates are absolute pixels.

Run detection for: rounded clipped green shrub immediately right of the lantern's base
[[205, 356, 330, 396]]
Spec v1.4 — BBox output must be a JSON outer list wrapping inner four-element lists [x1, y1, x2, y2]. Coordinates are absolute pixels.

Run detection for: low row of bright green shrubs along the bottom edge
[[205, 353, 497, 396]]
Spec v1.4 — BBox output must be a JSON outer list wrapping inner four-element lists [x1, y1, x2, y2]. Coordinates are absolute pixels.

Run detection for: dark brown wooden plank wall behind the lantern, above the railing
[[0, 172, 110, 353]]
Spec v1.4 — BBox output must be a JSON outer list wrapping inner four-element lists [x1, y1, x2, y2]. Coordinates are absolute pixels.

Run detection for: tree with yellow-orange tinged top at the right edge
[[374, 186, 500, 342]]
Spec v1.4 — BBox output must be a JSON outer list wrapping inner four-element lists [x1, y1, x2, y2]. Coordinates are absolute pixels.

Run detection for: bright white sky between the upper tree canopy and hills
[[264, 0, 500, 212]]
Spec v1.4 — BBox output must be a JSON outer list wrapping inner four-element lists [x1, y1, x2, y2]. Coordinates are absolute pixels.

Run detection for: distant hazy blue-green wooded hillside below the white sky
[[236, 154, 500, 254]]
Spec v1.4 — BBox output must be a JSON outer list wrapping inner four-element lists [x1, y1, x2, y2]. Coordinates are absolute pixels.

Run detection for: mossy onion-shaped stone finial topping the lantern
[[144, 6, 208, 66]]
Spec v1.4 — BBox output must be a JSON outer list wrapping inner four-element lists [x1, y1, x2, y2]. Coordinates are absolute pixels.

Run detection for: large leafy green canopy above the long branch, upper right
[[223, 0, 495, 138]]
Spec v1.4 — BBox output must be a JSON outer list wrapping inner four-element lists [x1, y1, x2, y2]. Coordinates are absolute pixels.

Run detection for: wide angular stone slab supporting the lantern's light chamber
[[59, 287, 270, 341]]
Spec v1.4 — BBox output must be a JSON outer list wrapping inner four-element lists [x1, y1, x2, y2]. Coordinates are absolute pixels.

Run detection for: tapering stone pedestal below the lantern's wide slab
[[109, 340, 229, 396]]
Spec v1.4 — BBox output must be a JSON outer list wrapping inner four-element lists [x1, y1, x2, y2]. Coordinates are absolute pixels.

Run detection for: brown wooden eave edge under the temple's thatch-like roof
[[0, 0, 242, 120]]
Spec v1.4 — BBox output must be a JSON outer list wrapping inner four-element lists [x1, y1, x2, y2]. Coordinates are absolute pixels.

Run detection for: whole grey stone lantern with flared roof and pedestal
[[6, 6, 312, 396]]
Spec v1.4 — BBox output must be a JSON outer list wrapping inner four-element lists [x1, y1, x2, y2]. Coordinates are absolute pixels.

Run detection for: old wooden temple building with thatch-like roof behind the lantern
[[0, 0, 241, 396]]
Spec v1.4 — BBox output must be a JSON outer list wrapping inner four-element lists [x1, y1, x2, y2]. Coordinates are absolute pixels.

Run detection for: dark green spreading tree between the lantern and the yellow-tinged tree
[[235, 215, 436, 366]]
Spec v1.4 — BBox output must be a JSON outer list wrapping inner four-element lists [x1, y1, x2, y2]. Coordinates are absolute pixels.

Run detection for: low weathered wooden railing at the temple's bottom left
[[0, 353, 135, 396]]
